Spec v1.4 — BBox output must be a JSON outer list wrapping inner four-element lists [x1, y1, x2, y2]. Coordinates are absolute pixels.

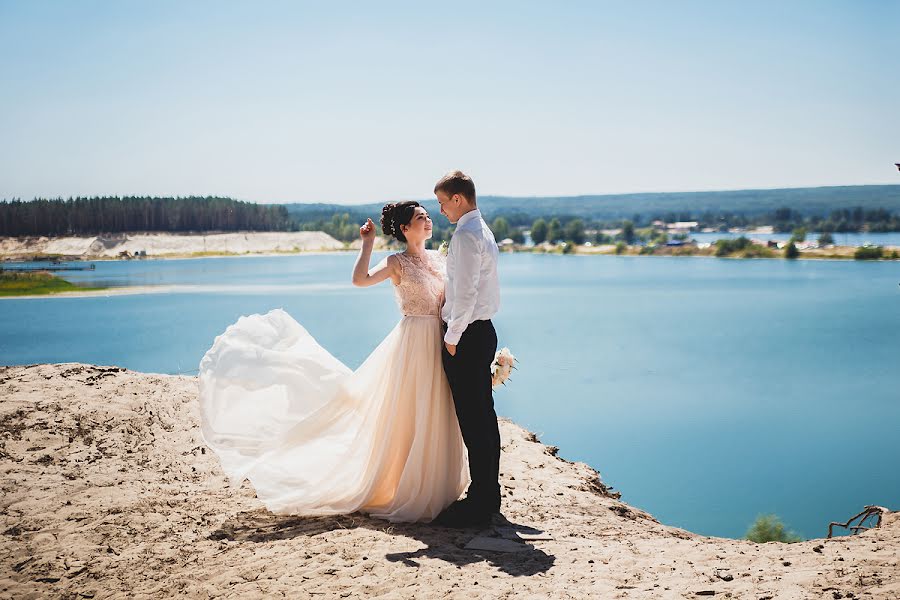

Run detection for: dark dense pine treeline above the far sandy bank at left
[[0, 196, 297, 236]]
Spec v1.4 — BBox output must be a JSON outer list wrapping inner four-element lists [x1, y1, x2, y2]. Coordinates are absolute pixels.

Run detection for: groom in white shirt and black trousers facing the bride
[[434, 171, 500, 527]]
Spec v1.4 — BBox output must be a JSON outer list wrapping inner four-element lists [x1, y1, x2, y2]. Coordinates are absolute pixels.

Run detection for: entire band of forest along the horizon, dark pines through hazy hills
[[0, 185, 900, 243]]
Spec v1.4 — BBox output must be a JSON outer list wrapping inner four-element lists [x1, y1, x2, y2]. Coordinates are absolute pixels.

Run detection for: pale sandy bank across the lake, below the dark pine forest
[[0, 231, 344, 258]]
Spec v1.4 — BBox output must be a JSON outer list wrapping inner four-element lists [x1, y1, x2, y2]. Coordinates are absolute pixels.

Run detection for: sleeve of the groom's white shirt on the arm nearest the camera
[[444, 231, 481, 346]]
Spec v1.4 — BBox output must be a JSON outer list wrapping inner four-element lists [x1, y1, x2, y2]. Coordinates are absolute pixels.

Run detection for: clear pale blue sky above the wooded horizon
[[0, 0, 900, 203]]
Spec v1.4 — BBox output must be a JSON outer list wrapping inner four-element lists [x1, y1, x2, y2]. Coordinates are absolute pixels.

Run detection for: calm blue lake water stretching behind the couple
[[0, 254, 900, 537]]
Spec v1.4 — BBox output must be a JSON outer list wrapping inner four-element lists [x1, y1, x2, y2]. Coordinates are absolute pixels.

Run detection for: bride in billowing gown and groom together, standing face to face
[[199, 171, 500, 527]]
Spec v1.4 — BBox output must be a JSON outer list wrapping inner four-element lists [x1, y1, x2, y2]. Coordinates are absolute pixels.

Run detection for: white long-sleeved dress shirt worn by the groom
[[441, 208, 500, 346]]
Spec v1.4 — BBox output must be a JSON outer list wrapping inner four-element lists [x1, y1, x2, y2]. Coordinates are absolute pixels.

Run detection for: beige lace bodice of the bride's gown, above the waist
[[394, 250, 447, 317]]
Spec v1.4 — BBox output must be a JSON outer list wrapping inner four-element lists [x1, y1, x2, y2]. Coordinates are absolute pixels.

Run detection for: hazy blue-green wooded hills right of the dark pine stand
[[286, 185, 900, 243]]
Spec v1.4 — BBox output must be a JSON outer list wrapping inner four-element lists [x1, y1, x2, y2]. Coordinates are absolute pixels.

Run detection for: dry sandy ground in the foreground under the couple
[[0, 363, 900, 600]]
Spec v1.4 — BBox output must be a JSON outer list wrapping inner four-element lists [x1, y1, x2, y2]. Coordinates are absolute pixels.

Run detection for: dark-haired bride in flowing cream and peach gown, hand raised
[[199, 202, 469, 522]]
